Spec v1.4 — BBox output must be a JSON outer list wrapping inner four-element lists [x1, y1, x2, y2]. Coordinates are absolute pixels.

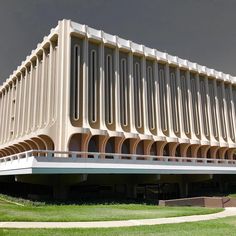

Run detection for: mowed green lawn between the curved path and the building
[[0, 200, 222, 222]]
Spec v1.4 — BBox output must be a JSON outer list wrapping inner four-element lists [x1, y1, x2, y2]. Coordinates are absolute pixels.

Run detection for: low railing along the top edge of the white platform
[[0, 150, 236, 166]]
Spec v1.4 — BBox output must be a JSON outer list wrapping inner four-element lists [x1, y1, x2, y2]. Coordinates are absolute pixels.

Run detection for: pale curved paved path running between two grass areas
[[0, 207, 236, 228]]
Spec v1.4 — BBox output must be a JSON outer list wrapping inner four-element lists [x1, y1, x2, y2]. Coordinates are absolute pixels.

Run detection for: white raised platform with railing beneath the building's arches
[[0, 150, 236, 175]]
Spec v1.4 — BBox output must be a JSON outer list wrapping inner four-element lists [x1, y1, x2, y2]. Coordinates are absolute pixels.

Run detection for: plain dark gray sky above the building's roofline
[[0, 0, 236, 83]]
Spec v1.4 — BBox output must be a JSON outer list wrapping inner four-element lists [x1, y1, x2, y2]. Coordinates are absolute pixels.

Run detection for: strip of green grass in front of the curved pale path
[[0, 217, 236, 236]]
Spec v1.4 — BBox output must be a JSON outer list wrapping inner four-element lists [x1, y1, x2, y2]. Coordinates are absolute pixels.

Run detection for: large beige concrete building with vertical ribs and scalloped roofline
[[0, 20, 236, 198]]
